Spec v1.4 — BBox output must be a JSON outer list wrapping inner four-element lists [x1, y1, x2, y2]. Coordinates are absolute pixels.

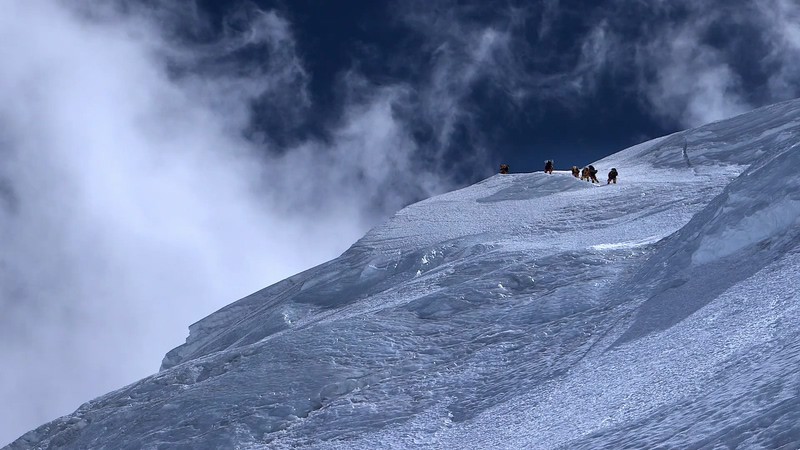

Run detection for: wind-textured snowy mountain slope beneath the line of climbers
[[10, 102, 800, 449]]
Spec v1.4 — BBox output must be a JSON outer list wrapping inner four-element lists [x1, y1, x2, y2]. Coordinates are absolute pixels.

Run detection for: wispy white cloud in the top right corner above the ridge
[[581, 0, 800, 127]]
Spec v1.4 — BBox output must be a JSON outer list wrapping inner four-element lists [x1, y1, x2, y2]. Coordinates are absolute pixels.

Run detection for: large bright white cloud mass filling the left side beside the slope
[[0, 1, 456, 442]]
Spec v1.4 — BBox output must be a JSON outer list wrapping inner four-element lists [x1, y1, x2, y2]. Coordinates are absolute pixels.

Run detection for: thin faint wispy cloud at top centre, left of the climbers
[[398, 2, 529, 171]]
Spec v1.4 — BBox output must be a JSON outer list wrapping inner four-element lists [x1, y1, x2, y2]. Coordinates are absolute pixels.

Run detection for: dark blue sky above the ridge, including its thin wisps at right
[[162, 0, 797, 184]]
